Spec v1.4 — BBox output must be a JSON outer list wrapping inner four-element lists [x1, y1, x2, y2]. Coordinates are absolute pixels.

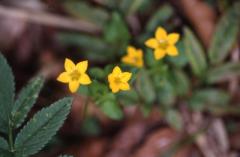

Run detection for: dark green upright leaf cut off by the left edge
[[0, 53, 15, 132]]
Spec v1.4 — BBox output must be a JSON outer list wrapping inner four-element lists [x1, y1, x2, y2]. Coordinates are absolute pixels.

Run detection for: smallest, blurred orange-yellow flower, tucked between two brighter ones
[[122, 46, 143, 68]]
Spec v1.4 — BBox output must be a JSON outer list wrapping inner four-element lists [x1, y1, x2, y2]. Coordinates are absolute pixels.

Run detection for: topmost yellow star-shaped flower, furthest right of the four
[[145, 27, 179, 60]]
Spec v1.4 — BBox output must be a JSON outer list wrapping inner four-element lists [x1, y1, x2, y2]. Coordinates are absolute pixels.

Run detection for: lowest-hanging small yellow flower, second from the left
[[108, 66, 132, 93]]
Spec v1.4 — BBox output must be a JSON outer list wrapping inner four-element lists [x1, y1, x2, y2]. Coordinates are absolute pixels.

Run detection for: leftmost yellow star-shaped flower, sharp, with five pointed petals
[[57, 58, 91, 93]]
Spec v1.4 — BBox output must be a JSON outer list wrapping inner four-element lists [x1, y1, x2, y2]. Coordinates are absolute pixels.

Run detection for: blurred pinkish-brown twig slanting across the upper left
[[0, 5, 101, 33]]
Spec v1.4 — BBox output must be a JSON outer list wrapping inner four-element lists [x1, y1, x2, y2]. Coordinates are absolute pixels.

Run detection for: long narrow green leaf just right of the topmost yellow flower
[[183, 28, 207, 77]]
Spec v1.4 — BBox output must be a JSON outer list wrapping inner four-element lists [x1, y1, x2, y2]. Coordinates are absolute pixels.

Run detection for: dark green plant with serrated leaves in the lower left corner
[[0, 54, 72, 157]]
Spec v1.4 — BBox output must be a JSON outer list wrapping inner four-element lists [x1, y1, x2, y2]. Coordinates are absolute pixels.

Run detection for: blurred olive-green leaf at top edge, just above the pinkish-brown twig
[[64, 1, 109, 27]]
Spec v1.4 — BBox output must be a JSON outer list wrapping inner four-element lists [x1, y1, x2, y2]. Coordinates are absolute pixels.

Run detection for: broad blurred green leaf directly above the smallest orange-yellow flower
[[104, 12, 130, 46]]
